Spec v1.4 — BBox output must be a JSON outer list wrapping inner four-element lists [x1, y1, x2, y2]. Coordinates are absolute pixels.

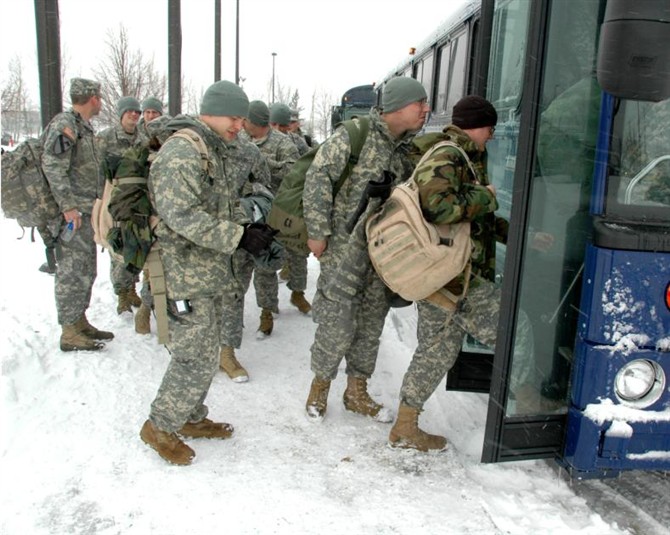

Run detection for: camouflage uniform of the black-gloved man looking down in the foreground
[[149, 117, 246, 433]]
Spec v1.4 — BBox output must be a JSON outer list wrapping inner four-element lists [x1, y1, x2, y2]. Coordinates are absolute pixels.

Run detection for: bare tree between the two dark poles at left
[[94, 24, 167, 126]]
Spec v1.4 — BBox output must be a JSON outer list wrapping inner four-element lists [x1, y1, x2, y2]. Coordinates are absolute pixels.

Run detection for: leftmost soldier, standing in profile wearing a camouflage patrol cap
[[42, 78, 114, 351]]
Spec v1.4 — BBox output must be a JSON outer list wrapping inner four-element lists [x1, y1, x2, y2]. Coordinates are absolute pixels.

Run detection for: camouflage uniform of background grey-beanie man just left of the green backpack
[[235, 128, 296, 314]]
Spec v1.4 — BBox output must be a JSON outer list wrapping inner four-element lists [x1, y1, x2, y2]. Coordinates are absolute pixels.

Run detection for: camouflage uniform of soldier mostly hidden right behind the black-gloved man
[[221, 137, 276, 348]]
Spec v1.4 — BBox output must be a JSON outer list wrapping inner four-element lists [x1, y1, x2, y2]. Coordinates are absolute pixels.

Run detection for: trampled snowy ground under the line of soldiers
[[0, 219, 667, 535]]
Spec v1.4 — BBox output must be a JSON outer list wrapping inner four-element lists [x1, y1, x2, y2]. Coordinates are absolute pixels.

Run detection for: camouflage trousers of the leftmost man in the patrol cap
[[54, 214, 97, 325]]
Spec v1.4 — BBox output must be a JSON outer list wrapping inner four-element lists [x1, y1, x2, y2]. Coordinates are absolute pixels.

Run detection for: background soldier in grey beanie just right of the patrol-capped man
[[97, 97, 143, 314]]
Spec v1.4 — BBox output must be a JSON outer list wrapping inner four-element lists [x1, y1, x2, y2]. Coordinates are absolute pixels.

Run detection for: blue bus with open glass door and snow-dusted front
[[376, 0, 670, 478]]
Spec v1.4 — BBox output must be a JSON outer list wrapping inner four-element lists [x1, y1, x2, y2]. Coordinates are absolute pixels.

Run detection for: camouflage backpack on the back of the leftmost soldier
[[1, 138, 61, 229]]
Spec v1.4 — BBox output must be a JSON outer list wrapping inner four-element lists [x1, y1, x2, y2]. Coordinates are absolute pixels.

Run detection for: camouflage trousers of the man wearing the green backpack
[[311, 267, 389, 380]]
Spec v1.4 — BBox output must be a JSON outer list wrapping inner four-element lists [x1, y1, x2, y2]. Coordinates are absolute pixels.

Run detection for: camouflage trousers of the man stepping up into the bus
[[400, 280, 533, 409]]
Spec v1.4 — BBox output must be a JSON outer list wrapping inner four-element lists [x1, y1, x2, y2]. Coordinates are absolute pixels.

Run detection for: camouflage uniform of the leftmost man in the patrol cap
[[42, 104, 103, 325]]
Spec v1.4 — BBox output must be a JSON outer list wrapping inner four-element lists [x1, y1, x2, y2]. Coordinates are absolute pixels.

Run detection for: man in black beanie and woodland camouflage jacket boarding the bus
[[389, 95, 552, 451]]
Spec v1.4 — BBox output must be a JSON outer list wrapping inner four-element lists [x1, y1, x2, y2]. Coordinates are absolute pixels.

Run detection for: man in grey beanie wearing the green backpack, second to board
[[303, 77, 430, 422]]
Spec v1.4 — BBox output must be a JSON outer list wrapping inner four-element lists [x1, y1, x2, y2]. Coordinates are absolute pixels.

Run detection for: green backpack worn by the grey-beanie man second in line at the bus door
[[267, 115, 370, 254]]
